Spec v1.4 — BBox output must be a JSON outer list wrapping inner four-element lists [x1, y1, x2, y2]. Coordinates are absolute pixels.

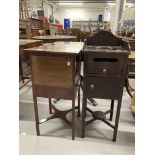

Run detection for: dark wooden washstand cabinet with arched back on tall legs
[[82, 31, 130, 141]]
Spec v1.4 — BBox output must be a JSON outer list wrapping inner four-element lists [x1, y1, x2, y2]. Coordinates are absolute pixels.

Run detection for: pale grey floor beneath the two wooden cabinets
[[19, 80, 135, 155]]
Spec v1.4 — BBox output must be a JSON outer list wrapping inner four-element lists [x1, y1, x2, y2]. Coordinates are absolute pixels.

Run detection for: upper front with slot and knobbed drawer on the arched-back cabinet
[[86, 53, 128, 76]]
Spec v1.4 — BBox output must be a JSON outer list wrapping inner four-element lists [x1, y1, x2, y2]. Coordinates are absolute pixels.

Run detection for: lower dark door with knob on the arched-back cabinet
[[86, 77, 124, 99]]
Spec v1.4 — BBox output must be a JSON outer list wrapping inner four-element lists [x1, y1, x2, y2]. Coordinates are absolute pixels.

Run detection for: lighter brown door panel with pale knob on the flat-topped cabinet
[[31, 55, 73, 87]]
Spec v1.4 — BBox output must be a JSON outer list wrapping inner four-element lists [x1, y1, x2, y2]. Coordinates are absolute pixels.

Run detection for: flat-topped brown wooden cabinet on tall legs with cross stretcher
[[28, 42, 83, 140]]
